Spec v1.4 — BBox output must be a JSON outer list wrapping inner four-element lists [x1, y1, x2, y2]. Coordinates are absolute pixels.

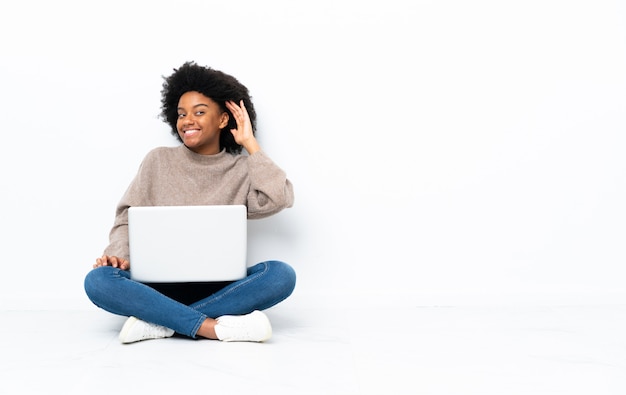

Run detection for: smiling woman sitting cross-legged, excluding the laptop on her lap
[[84, 62, 296, 343]]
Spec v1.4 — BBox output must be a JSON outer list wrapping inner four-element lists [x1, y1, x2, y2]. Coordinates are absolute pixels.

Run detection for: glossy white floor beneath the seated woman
[[0, 303, 626, 395]]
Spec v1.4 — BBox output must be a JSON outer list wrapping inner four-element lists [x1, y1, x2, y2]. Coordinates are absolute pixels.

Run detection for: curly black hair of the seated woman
[[160, 61, 256, 154]]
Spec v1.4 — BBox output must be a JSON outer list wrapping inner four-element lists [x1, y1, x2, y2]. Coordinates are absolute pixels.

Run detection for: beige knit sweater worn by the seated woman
[[104, 144, 294, 265]]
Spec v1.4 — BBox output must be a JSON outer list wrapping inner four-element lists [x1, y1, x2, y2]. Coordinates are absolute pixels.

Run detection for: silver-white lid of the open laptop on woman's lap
[[128, 205, 247, 283]]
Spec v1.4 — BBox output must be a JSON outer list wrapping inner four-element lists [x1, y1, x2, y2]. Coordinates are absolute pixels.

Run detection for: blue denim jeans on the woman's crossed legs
[[85, 261, 296, 338]]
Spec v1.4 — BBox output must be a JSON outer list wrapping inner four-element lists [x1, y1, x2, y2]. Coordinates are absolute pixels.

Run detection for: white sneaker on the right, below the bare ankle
[[215, 310, 272, 342]]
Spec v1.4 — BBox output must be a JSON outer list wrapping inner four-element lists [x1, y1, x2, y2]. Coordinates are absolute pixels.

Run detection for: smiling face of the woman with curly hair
[[176, 91, 228, 155]]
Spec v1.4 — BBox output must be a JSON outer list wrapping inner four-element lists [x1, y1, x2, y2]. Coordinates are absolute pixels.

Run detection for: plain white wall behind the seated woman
[[0, 0, 626, 308]]
